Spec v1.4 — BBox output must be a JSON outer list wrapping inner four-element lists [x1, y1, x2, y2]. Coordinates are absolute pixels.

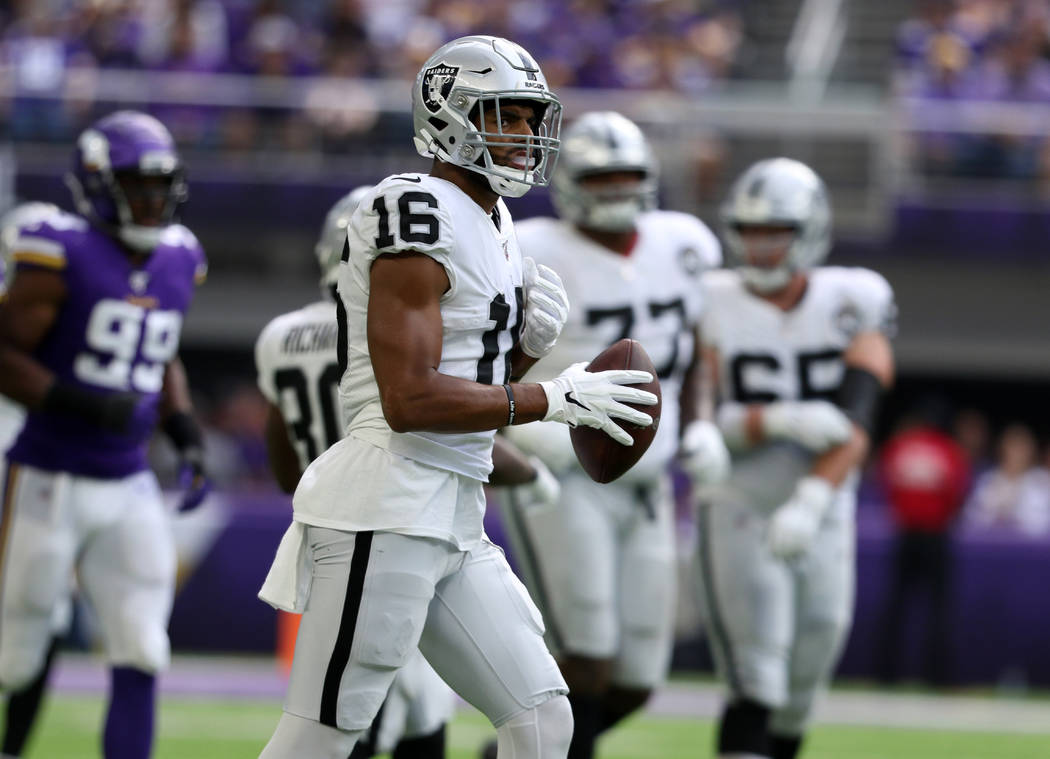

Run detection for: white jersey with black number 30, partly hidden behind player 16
[[255, 300, 343, 470]]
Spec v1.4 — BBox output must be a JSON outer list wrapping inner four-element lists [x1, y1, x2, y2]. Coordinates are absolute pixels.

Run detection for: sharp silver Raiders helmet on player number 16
[[412, 36, 562, 197]]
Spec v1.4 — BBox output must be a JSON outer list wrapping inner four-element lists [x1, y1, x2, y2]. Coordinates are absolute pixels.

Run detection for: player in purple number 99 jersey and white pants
[[0, 111, 208, 759]]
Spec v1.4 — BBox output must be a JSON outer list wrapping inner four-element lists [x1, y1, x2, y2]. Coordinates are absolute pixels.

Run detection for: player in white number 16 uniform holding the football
[[260, 36, 656, 759]]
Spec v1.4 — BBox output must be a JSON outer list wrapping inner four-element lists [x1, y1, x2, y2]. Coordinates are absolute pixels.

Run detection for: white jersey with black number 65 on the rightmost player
[[701, 267, 897, 510]]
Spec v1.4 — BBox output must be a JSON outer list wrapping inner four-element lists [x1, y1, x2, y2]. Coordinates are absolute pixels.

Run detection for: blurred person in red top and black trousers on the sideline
[[879, 398, 970, 686]]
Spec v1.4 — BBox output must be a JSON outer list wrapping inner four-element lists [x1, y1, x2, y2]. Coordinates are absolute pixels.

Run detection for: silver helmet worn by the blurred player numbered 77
[[551, 110, 657, 232]]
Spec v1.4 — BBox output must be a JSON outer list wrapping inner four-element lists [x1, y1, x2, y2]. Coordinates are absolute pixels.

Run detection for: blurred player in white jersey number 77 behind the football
[[503, 111, 729, 759]]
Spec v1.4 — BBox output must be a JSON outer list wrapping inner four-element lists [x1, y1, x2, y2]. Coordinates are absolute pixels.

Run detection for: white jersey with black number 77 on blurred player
[[512, 211, 721, 482]]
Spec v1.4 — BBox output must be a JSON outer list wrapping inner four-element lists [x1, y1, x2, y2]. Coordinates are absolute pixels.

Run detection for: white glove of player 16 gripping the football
[[540, 361, 656, 445]]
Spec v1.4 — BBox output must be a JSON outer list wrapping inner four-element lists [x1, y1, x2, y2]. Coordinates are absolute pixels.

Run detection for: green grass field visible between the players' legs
[[16, 695, 1050, 759]]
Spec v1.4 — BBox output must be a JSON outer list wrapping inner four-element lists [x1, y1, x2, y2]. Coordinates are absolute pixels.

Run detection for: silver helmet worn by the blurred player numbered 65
[[720, 159, 832, 292]]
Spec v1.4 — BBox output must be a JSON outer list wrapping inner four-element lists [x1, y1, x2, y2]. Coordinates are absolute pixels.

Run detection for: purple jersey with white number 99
[[7, 214, 206, 479]]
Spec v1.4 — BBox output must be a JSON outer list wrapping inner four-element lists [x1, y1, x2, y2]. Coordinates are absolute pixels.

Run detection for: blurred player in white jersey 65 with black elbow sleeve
[[698, 159, 896, 759]]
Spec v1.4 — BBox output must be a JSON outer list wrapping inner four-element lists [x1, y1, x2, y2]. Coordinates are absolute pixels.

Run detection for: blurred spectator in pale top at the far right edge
[[966, 424, 1050, 535]]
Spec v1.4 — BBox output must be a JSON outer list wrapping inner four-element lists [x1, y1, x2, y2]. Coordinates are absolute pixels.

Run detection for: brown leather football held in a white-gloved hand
[[569, 338, 663, 483]]
